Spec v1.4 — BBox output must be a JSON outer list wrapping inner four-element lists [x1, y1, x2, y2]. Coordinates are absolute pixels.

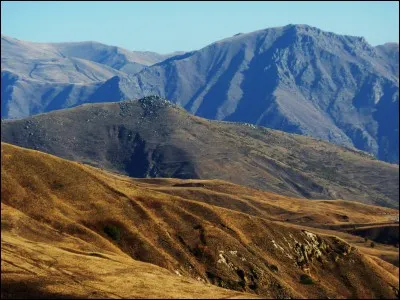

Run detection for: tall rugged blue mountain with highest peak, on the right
[[124, 25, 399, 163]]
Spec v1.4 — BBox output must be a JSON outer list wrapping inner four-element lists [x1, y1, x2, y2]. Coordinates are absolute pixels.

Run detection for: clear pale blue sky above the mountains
[[1, 1, 399, 54]]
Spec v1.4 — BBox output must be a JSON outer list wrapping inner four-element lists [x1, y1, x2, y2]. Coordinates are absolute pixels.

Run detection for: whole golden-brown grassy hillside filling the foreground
[[1, 143, 399, 298]]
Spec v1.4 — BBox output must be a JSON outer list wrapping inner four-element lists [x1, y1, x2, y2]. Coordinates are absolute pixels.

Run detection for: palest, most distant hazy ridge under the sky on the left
[[1, 35, 182, 83]]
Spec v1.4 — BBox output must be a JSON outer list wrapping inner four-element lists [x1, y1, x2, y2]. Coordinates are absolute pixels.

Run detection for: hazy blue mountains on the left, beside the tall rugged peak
[[1, 35, 182, 119]]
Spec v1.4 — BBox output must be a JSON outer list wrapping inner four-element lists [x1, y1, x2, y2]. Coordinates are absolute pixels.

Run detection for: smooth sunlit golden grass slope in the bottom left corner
[[1, 234, 253, 299]]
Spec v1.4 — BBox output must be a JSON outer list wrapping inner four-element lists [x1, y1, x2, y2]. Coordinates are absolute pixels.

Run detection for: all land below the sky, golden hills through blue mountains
[[0, 25, 399, 299]]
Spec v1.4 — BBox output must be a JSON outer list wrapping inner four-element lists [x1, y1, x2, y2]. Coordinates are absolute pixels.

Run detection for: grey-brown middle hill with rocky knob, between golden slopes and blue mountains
[[1, 97, 399, 207]]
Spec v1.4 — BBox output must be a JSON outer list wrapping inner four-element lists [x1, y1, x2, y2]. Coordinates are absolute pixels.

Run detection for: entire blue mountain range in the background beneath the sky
[[1, 25, 399, 163]]
